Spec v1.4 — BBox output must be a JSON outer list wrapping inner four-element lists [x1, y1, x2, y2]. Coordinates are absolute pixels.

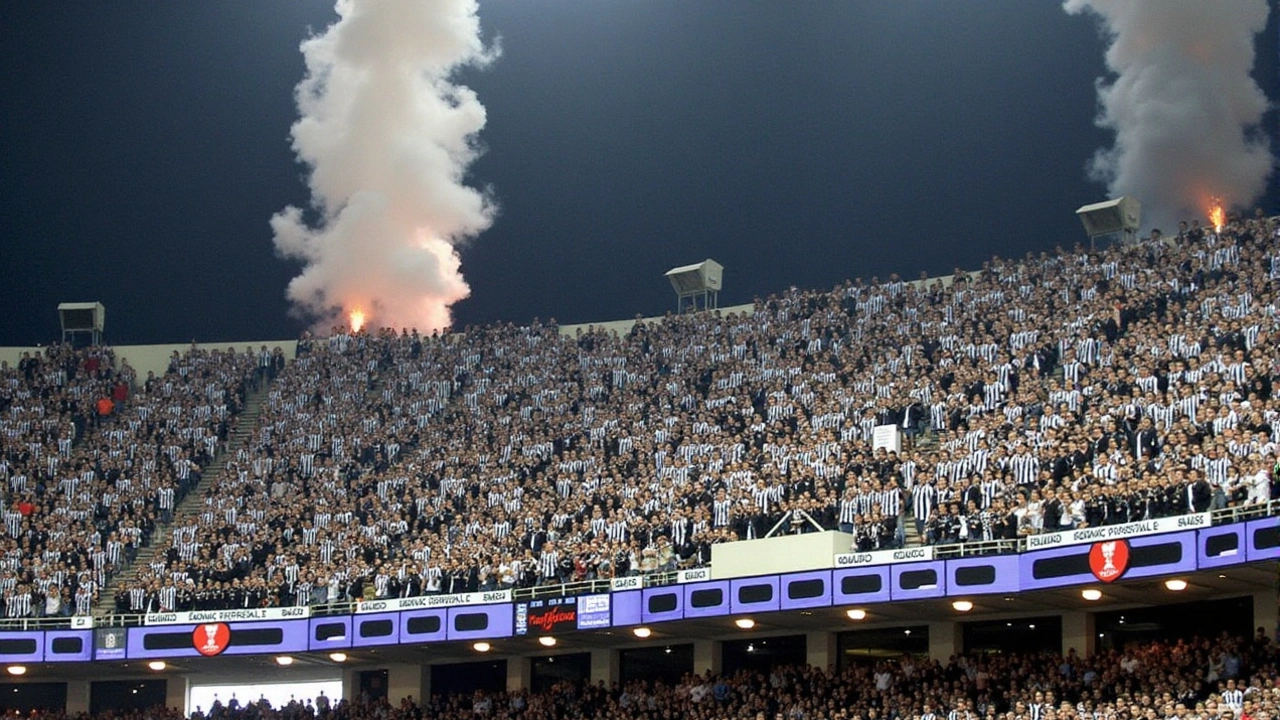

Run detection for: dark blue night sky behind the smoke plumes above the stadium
[[0, 0, 1280, 345]]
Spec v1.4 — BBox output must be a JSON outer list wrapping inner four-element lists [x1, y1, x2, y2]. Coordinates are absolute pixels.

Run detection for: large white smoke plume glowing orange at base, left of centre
[[271, 0, 497, 331]]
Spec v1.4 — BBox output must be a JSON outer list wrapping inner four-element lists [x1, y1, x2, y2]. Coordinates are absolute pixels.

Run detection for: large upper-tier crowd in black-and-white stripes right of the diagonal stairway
[[74, 207, 1280, 611]]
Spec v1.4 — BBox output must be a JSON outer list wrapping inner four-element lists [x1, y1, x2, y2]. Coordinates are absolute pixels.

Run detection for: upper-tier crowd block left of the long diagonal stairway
[[0, 345, 257, 618]]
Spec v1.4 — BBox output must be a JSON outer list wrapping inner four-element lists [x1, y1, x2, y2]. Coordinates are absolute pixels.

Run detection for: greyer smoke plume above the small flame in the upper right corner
[[1064, 0, 1274, 232]]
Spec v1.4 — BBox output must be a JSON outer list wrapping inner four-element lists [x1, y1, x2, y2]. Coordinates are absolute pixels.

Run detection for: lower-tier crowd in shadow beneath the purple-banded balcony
[[17, 635, 1280, 720]]
